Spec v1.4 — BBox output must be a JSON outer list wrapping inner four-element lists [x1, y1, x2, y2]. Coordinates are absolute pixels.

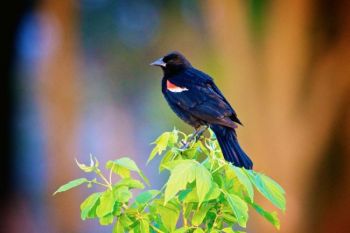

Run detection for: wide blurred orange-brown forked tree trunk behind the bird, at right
[[204, 0, 350, 233]]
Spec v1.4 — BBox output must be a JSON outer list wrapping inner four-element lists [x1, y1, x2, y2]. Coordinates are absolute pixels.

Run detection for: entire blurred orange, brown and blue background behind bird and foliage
[[0, 0, 350, 233]]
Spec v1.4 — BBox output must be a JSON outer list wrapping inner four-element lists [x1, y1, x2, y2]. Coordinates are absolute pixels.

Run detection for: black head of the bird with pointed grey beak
[[150, 52, 191, 73]]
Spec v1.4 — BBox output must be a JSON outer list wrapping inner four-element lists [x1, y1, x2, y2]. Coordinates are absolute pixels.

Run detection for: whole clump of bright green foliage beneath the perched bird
[[55, 129, 286, 233]]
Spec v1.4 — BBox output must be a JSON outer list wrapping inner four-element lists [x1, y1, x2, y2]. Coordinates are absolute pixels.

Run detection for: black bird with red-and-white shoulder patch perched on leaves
[[151, 52, 253, 169]]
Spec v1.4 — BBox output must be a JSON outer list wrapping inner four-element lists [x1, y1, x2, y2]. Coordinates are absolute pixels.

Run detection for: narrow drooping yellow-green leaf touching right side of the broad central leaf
[[196, 165, 212, 205]]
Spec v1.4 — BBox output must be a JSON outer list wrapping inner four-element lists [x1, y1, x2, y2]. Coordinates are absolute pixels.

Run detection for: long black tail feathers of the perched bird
[[210, 125, 253, 169]]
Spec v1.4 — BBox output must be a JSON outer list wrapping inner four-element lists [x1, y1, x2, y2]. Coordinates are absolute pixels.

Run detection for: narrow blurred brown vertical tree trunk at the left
[[38, 1, 81, 233]]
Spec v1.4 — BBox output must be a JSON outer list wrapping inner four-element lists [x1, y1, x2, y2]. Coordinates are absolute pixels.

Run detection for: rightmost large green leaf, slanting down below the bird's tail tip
[[248, 171, 286, 211]]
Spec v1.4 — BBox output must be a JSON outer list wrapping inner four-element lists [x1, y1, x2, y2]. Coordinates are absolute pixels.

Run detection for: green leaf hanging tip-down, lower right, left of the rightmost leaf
[[224, 192, 248, 227]]
